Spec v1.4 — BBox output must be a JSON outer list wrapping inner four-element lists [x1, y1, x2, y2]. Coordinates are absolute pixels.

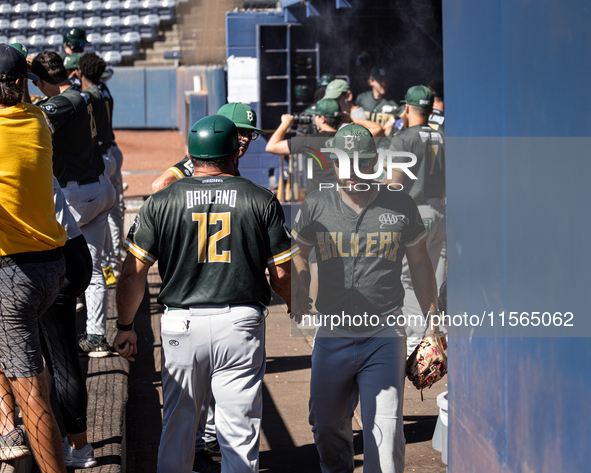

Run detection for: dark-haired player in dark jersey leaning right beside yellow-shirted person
[[31, 51, 115, 357]]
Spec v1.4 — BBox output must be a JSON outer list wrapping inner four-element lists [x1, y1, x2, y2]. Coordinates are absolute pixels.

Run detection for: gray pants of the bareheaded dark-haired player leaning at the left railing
[[62, 173, 115, 335]]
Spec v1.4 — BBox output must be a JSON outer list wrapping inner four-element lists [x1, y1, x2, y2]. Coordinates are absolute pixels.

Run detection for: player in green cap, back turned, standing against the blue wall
[[384, 85, 446, 354]]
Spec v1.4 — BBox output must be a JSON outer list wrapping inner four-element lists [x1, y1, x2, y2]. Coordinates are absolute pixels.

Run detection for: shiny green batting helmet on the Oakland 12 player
[[189, 115, 240, 159]]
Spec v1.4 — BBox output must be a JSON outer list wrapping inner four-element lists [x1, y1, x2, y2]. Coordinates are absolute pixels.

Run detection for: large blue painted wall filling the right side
[[443, 0, 591, 473]]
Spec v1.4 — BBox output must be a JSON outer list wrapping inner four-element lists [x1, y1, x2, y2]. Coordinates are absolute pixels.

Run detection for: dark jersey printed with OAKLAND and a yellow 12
[[124, 176, 298, 308]]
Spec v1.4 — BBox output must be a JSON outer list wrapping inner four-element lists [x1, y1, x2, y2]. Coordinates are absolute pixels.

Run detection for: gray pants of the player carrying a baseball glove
[[309, 322, 406, 473]]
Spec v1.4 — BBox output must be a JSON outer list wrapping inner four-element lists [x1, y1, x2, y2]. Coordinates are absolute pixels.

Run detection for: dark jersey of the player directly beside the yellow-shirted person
[[39, 87, 105, 185]]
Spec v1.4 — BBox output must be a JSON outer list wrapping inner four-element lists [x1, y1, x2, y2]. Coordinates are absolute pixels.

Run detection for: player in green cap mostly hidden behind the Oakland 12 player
[[152, 102, 265, 192]]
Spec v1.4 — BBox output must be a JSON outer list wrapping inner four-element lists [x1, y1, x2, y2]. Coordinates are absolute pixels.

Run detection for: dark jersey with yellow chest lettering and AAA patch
[[292, 183, 427, 316]]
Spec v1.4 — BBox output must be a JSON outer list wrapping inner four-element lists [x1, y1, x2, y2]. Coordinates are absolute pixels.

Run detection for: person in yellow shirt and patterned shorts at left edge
[[0, 44, 67, 473]]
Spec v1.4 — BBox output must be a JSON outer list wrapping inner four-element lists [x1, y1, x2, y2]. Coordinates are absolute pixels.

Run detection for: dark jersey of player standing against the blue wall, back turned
[[390, 125, 445, 205]]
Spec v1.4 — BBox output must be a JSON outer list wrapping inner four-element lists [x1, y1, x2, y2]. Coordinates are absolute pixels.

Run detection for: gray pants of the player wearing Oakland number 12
[[158, 306, 265, 473]]
